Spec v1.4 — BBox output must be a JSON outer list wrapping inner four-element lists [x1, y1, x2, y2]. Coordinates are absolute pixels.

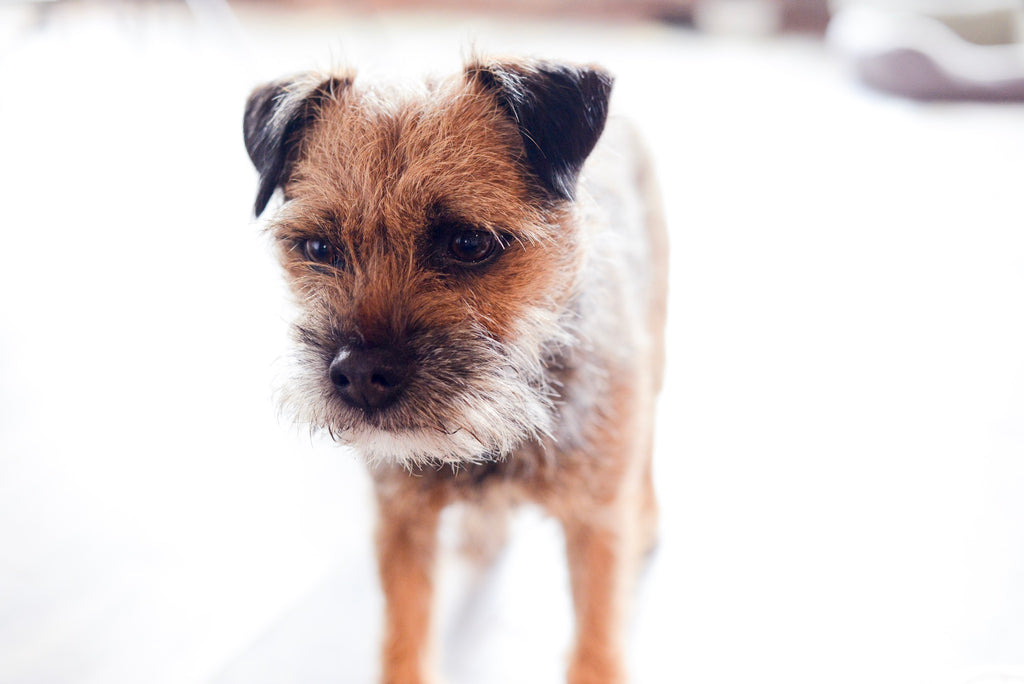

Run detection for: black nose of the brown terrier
[[329, 347, 410, 411]]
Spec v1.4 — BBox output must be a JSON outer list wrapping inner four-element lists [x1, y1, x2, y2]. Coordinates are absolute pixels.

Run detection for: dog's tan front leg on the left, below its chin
[[377, 473, 443, 684]]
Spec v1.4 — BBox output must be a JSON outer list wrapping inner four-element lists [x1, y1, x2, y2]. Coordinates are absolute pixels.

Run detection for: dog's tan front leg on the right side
[[563, 510, 633, 684]]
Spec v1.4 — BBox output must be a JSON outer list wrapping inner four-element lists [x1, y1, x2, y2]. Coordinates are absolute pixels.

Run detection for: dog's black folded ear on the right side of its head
[[466, 61, 612, 200]]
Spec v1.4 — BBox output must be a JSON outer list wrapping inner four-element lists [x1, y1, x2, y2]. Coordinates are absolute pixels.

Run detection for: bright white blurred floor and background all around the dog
[[0, 0, 1024, 684]]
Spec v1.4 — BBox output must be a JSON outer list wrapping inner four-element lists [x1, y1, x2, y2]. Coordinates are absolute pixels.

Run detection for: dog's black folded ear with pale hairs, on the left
[[243, 75, 351, 216]]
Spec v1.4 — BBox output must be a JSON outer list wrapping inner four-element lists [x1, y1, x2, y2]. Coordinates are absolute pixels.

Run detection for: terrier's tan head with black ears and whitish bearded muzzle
[[245, 63, 611, 465]]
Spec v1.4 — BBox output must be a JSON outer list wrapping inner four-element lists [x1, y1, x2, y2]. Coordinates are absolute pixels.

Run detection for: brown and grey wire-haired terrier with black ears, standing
[[244, 57, 668, 684]]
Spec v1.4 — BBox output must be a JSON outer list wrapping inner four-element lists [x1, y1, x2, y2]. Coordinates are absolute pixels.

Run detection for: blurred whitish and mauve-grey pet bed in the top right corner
[[826, 0, 1024, 100]]
